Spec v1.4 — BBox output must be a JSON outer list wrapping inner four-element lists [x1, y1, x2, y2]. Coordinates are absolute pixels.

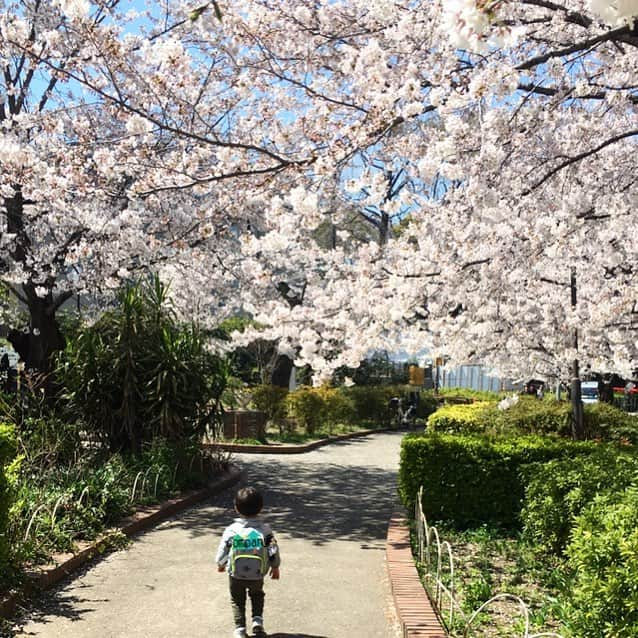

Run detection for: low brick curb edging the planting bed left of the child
[[0, 465, 241, 619]]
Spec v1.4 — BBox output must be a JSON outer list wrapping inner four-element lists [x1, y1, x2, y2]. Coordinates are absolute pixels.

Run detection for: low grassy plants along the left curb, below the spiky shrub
[[8, 439, 227, 576]]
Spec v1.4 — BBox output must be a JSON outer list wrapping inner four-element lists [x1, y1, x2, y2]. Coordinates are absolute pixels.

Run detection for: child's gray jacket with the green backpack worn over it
[[215, 517, 281, 580]]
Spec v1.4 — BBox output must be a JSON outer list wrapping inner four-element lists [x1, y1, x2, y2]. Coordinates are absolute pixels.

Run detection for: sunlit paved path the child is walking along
[[14, 432, 402, 638]]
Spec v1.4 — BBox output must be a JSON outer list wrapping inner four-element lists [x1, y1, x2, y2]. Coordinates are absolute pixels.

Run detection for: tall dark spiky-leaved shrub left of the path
[[57, 278, 227, 451]]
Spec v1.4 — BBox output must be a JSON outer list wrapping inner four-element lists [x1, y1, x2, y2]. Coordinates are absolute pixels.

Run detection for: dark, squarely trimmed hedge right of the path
[[399, 434, 596, 527]]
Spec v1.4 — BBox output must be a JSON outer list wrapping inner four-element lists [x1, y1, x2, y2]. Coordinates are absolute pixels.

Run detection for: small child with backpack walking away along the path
[[215, 487, 281, 638]]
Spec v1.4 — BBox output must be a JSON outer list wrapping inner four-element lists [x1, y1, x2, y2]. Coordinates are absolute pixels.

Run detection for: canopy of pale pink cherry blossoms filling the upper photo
[[2, 0, 638, 430]]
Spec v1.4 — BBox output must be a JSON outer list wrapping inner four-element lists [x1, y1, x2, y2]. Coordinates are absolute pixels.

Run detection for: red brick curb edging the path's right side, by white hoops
[[385, 514, 447, 638]]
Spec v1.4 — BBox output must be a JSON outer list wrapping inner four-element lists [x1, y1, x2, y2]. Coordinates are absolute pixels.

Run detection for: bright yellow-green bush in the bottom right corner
[[567, 487, 638, 638]]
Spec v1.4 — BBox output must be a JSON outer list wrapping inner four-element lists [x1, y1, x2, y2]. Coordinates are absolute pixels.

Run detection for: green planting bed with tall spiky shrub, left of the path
[[0, 277, 235, 588]]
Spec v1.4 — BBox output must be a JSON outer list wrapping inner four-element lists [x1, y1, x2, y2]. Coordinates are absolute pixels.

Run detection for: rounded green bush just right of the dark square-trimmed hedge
[[521, 447, 638, 554]]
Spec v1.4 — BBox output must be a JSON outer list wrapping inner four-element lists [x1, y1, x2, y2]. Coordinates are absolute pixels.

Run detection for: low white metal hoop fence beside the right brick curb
[[414, 487, 563, 638]]
